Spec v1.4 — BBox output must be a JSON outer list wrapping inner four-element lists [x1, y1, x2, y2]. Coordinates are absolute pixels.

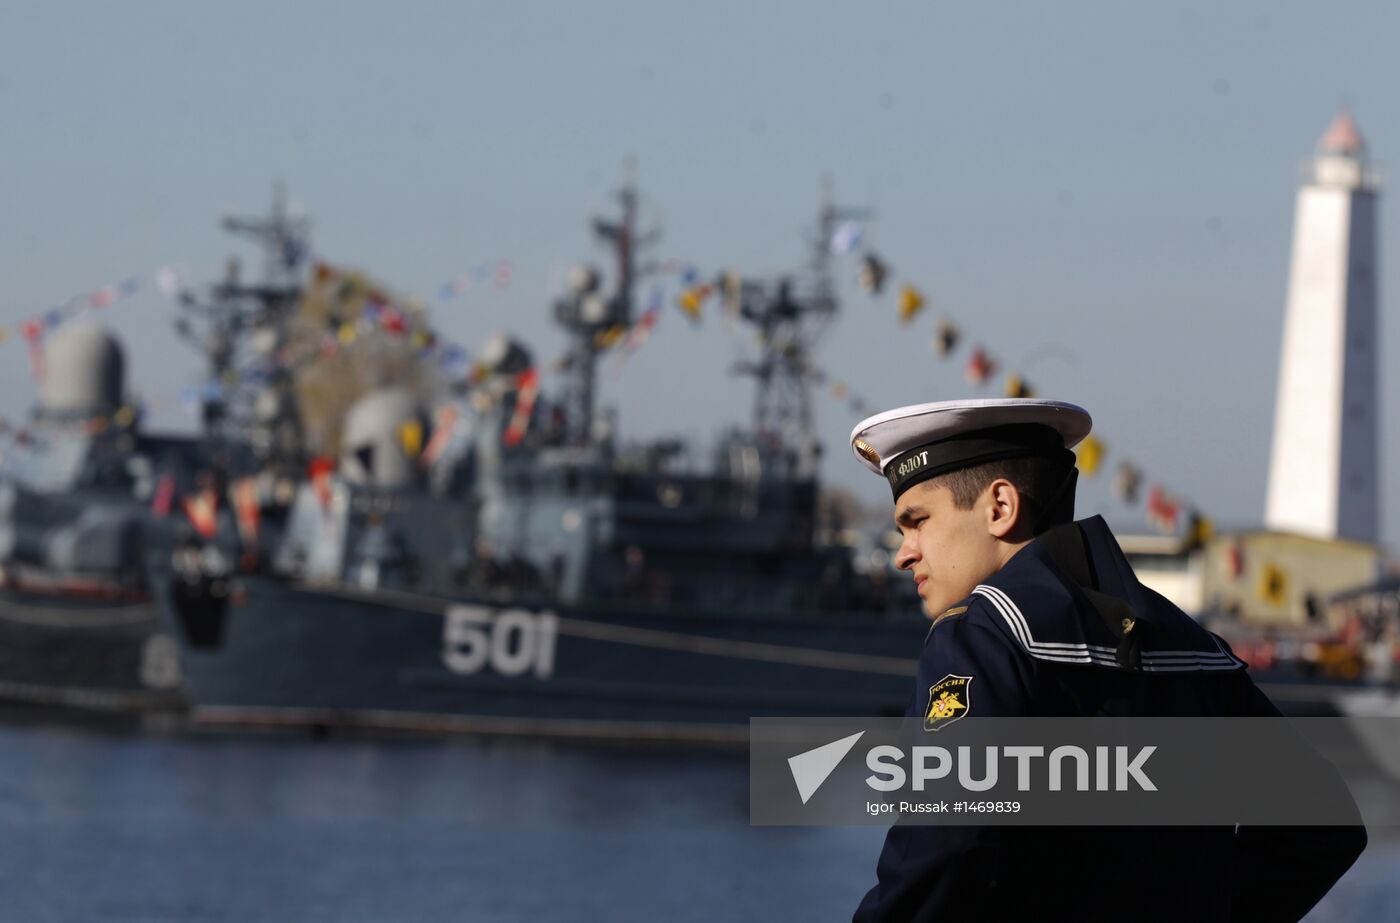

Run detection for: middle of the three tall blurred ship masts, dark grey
[[554, 162, 661, 445]]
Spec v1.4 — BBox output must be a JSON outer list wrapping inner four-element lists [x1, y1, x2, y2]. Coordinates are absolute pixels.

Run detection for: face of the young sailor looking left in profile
[[895, 480, 1001, 618]]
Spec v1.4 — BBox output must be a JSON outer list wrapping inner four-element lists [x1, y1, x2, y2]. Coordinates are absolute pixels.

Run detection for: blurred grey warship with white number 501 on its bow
[[147, 182, 927, 741]]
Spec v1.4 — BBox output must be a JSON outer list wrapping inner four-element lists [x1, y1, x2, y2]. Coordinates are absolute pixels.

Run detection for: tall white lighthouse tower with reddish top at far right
[[1264, 112, 1380, 542]]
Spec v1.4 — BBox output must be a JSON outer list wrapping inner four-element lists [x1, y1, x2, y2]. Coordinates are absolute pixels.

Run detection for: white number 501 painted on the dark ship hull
[[442, 605, 559, 679]]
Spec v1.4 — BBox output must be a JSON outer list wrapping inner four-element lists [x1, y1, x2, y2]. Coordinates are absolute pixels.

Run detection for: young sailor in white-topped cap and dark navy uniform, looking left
[[851, 399, 1366, 923]]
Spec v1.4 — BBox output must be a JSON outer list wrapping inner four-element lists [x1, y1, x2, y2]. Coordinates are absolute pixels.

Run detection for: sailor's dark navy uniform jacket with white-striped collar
[[855, 517, 1366, 923]]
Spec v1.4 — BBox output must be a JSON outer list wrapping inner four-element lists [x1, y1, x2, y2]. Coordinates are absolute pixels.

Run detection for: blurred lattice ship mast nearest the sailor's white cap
[[735, 188, 872, 479]]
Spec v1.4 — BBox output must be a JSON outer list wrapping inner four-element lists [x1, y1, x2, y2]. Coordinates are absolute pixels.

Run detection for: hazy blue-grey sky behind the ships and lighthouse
[[0, 0, 1400, 545]]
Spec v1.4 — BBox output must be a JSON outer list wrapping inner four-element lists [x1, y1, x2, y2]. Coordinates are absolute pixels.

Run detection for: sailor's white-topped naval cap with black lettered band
[[851, 398, 1093, 499]]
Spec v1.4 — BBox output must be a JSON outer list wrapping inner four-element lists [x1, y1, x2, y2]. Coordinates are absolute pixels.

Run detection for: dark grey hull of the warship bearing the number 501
[[167, 577, 928, 741]]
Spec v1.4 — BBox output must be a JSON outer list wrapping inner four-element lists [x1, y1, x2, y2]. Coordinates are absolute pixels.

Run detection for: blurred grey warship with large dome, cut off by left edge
[[0, 321, 197, 713]]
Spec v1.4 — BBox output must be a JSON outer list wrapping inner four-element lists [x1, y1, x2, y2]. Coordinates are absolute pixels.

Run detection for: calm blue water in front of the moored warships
[[0, 726, 1400, 923]]
